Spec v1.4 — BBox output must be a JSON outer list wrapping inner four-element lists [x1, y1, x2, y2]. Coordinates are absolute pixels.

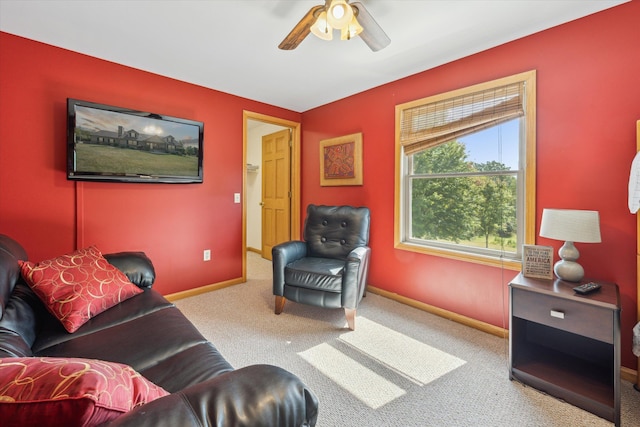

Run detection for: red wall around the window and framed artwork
[[302, 1, 640, 369]]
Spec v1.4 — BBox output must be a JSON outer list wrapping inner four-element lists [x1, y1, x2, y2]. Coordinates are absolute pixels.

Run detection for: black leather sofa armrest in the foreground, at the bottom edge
[[109, 365, 318, 427]]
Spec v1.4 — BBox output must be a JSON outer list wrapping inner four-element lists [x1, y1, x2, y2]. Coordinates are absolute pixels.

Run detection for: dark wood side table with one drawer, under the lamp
[[509, 273, 620, 426]]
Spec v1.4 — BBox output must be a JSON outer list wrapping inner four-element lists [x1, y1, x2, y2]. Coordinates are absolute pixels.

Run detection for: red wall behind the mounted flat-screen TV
[[0, 33, 301, 294]]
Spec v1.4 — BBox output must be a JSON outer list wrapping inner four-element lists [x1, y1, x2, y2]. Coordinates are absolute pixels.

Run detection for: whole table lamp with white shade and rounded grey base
[[540, 209, 602, 282]]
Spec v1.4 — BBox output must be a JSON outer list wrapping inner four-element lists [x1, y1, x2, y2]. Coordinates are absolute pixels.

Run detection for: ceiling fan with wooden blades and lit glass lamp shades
[[278, 0, 391, 52]]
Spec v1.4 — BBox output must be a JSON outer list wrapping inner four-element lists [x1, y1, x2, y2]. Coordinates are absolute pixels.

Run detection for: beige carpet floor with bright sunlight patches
[[176, 253, 640, 427]]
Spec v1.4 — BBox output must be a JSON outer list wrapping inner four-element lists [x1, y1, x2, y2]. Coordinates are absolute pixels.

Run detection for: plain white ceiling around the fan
[[0, 0, 626, 112]]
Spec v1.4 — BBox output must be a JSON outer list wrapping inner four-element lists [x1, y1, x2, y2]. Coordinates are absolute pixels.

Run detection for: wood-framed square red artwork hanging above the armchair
[[320, 133, 362, 187]]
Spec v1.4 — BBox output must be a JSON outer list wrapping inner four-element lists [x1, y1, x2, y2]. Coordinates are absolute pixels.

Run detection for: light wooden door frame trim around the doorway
[[241, 110, 301, 282]]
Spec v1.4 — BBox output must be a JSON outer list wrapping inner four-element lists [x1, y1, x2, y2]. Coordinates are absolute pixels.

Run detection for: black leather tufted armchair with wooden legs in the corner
[[272, 205, 371, 330]]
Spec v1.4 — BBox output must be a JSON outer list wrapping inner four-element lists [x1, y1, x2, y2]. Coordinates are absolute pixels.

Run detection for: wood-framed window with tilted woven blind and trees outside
[[395, 71, 535, 269]]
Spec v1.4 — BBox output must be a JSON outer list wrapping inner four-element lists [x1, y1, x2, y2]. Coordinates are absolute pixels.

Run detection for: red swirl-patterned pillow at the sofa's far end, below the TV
[[19, 246, 143, 333]]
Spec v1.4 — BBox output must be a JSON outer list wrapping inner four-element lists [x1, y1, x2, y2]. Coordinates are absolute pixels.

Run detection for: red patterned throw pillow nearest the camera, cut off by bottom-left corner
[[0, 357, 169, 427]]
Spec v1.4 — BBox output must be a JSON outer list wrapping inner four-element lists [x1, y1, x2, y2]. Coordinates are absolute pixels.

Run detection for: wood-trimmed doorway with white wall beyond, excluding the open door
[[242, 111, 300, 281]]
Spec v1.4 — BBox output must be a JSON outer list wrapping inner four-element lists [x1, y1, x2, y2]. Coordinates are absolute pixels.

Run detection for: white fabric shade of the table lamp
[[540, 209, 602, 243]]
